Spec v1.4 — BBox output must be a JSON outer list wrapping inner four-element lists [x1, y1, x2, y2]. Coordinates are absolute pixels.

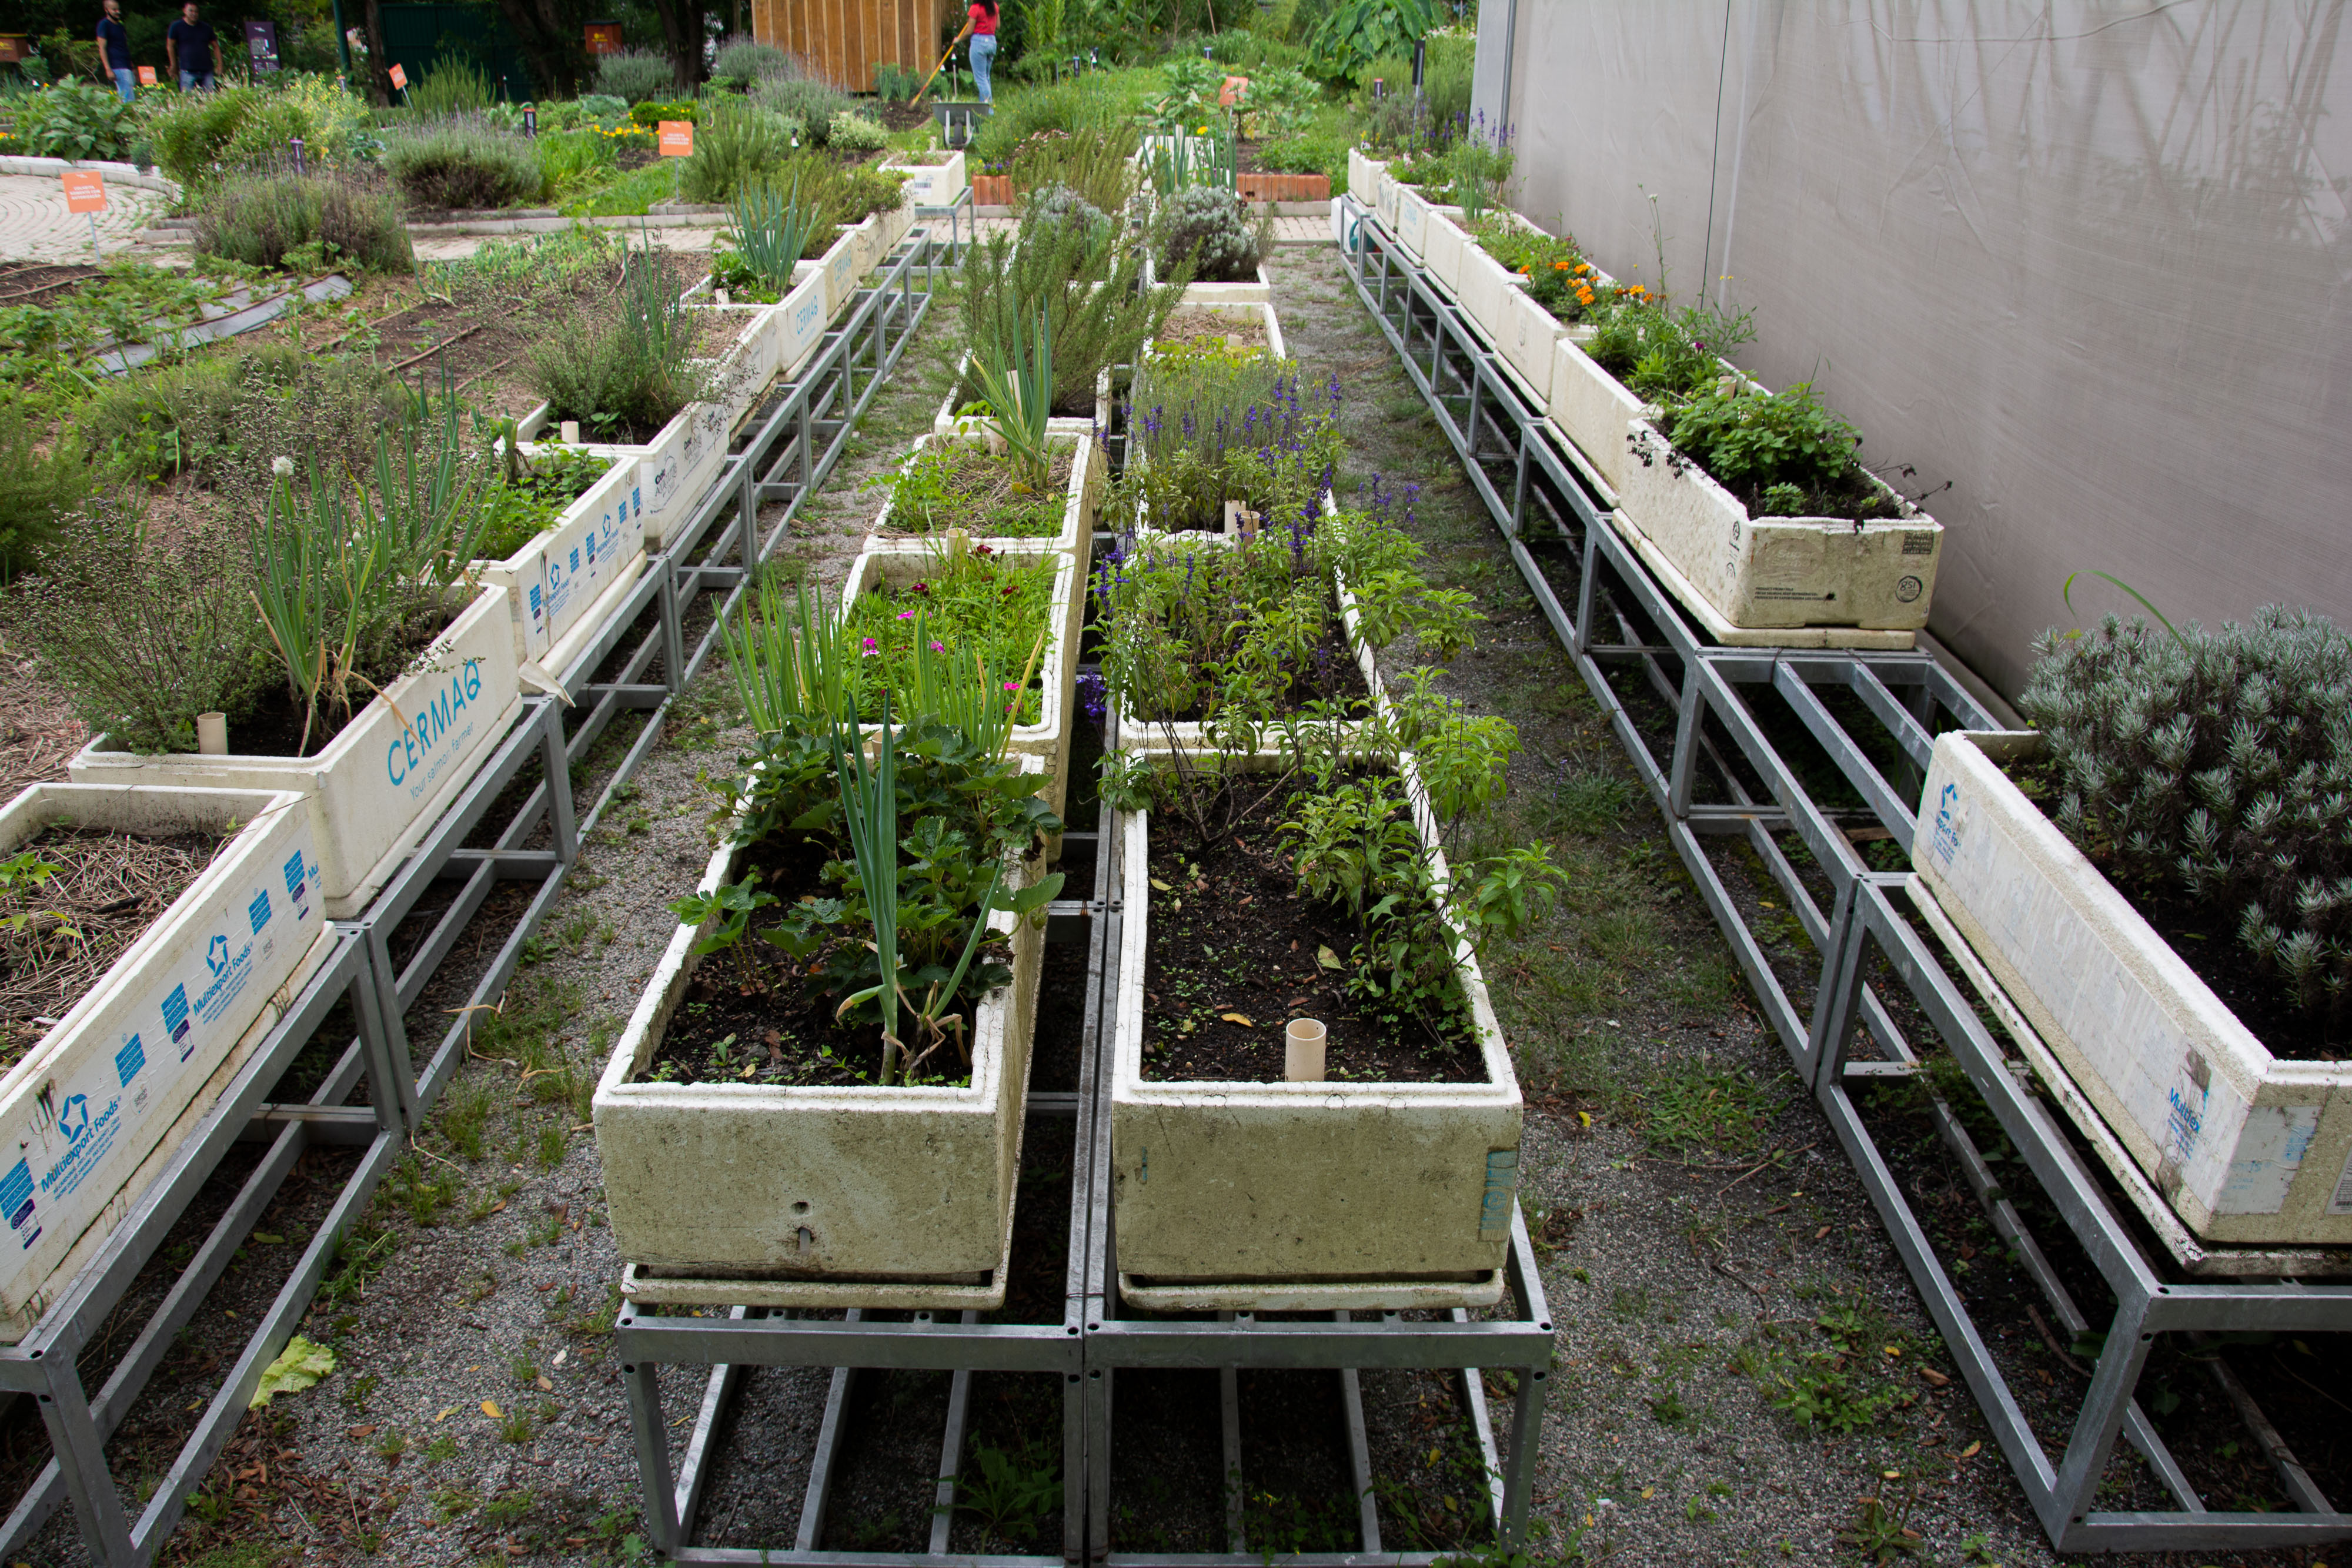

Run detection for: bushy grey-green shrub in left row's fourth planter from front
[[532, 252, 710, 440]]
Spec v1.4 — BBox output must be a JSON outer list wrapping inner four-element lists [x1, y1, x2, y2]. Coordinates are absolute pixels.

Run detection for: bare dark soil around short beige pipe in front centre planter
[[1129, 804, 1486, 1084]]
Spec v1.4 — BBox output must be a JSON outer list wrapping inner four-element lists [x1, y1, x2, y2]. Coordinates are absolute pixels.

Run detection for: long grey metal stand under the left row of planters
[[0, 230, 955, 1568]]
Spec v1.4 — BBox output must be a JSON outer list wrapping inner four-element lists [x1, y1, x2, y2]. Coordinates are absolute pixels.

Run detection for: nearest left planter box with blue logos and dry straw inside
[[0, 780, 334, 1342]]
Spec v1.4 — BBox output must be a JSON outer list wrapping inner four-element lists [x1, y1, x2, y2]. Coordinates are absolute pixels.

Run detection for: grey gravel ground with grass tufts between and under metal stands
[[0, 247, 2321, 1568]]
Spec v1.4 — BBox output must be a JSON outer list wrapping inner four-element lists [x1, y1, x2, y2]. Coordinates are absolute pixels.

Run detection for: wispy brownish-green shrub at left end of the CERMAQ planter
[[19, 501, 268, 753]]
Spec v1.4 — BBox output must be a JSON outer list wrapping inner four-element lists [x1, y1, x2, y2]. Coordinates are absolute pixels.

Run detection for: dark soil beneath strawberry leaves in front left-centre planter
[[637, 841, 1011, 1088]]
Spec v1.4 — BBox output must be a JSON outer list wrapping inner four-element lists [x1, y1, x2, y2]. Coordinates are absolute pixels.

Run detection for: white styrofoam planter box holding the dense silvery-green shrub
[[1912, 731, 2352, 1243]]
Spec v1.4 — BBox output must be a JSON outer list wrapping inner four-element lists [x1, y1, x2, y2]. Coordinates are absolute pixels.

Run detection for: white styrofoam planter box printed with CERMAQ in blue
[[68, 586, 522, 919]]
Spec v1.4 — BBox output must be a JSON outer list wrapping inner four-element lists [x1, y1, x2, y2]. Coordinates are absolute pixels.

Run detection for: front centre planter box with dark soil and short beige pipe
[[1110, 762, 1522, 1312]]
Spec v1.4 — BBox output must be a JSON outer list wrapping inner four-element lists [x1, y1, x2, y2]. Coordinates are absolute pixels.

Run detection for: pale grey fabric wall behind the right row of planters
[[1477, 0, 2352, 694]]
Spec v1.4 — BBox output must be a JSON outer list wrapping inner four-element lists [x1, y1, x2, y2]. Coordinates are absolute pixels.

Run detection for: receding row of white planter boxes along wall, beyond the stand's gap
[[1350, 153, 1943, 640]]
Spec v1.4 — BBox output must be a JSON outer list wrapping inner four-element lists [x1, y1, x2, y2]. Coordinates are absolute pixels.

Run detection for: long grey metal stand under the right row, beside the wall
[[1343, 200, 2352, 1552]]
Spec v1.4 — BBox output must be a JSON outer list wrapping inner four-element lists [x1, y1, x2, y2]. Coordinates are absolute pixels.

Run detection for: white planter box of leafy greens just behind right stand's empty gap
[[1618, 421, 1943, 633]]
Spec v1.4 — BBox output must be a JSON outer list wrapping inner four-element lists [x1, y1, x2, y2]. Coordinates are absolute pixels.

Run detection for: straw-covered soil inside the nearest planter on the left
[[0, 825, 228, 1067]]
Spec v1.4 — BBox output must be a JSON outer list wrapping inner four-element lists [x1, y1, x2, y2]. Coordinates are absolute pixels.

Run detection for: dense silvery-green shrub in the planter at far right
[[2018, 607, 2352, 1015]]
